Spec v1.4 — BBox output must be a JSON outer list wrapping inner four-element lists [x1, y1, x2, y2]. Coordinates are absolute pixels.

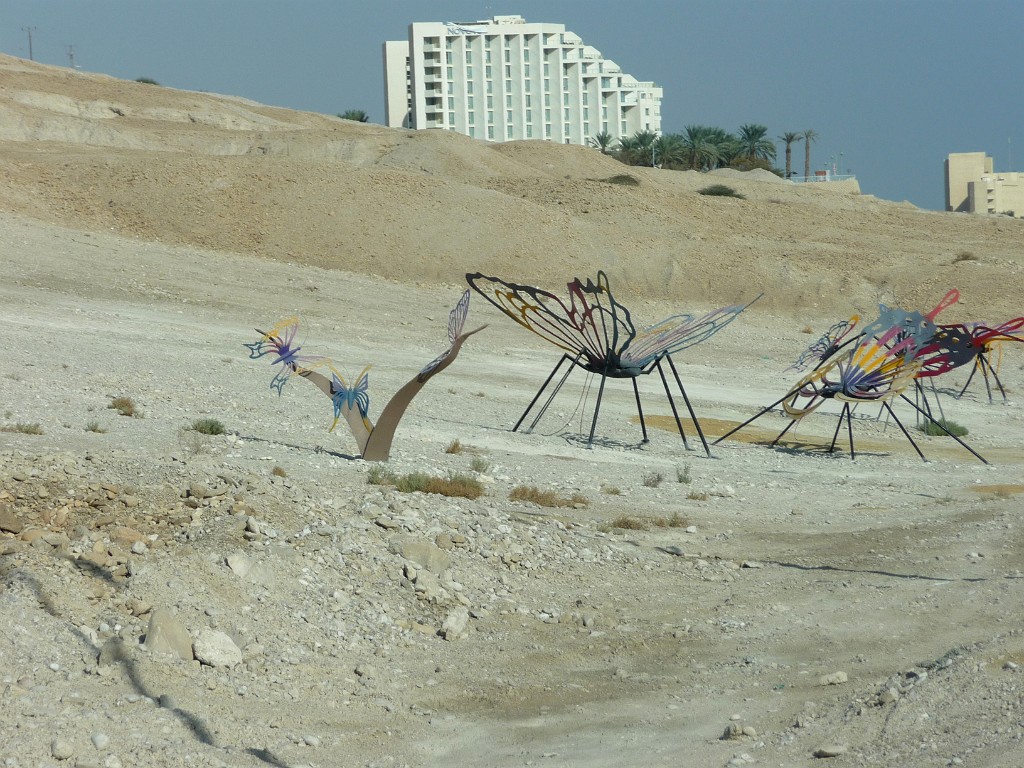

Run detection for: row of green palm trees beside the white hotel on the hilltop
[[588, 123, 817, 178]]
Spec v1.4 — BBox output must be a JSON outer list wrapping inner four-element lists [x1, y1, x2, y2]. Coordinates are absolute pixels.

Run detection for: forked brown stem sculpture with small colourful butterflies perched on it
[[246, 290, 486, 461]]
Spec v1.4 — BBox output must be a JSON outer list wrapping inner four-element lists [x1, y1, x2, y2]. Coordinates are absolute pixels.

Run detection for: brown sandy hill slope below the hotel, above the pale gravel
[[0, 56, 1024, 319]]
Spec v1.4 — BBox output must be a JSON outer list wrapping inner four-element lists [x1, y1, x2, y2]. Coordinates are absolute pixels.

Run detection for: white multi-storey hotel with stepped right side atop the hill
[[384, 16, 662, 144]]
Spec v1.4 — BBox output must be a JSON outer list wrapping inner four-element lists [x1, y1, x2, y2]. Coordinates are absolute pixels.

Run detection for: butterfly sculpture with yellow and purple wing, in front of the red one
[[716, 290, 987, 464]]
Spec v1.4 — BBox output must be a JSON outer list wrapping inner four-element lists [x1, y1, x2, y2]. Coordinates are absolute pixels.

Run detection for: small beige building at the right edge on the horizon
[[945, 152, 1024, 218]]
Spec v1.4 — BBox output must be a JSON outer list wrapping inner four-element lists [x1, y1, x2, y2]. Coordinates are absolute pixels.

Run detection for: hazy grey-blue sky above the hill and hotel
[[0, 0, 1024, 210]]
